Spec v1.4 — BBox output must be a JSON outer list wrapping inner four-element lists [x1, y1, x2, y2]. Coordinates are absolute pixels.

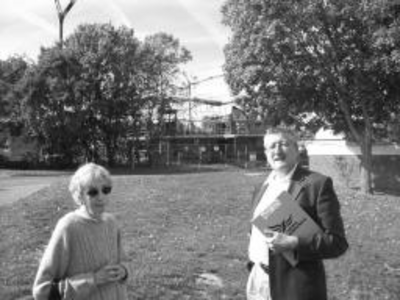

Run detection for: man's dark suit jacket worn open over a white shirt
[[252, 167, 348, 300]]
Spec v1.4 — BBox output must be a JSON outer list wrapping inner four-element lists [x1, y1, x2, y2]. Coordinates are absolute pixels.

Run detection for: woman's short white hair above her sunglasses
[[69, 163, 112, 205]]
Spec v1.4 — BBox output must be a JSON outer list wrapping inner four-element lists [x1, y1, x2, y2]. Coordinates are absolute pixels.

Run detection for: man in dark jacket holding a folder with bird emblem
[[247, 129, 348, 300]]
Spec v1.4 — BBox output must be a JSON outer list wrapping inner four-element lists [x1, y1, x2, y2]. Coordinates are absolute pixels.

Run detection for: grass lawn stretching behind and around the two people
[[0, 168, 400, 300]]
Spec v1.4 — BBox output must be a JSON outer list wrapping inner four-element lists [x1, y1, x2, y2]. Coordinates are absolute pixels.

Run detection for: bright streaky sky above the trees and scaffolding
[[0, 0, 230, 101]]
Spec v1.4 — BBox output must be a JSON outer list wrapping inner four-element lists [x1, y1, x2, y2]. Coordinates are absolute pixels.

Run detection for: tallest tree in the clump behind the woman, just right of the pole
[[65, 24, 143, 164]]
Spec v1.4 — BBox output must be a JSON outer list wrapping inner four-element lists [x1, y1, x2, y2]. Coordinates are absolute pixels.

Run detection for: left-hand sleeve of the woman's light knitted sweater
[[33, 220, 95, 300]]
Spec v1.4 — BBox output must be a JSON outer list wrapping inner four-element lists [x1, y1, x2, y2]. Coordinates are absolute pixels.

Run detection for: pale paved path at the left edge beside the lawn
[[0, 170, 66, 206]]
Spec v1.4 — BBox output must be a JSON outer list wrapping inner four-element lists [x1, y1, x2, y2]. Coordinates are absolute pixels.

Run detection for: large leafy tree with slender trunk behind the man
[[222, 0, 400, 193]]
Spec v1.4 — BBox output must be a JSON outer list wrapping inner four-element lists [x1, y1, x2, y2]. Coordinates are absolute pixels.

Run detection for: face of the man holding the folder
[[264, 133, 299, 172]]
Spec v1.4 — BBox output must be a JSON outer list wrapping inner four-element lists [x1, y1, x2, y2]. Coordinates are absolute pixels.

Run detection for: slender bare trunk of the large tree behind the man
[[360, 134, 373, 194]]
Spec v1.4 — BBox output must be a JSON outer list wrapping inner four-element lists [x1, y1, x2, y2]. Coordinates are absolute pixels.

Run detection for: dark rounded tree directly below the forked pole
[[23, 47, 87, 163]]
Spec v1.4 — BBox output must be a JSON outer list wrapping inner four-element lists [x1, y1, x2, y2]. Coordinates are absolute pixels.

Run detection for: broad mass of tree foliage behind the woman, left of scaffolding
[[19, 24, 190, 165]]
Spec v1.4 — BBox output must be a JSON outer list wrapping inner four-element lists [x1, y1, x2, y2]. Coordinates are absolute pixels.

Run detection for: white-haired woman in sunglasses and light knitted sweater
[[33, 163, 130, 300]]
